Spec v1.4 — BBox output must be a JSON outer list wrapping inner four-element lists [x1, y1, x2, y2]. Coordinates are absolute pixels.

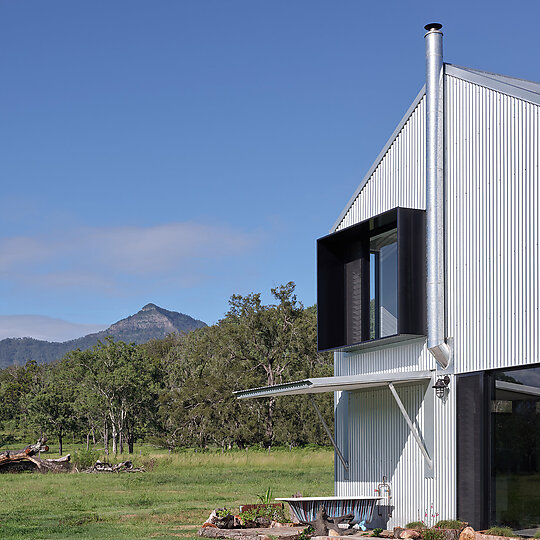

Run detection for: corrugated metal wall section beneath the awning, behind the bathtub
[[336, 377, 456, 528]]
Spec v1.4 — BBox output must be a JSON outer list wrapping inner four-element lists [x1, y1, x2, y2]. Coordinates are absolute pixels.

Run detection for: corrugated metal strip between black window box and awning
[[334, 339, 436, 376]]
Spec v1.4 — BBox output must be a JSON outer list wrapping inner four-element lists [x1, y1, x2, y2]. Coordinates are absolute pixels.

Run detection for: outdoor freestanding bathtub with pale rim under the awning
[[276, 495, 382, 525]]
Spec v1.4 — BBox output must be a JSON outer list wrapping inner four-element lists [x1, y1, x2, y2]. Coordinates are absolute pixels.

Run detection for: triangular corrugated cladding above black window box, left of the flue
[[336, 96, 426, 230]]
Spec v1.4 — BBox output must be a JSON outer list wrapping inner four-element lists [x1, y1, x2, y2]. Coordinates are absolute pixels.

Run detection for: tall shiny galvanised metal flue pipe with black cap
[[424, 23, 451, 369]]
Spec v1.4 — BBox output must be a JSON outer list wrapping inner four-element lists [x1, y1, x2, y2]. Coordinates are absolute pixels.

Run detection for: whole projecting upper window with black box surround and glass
[[317, 208, 426, 350]]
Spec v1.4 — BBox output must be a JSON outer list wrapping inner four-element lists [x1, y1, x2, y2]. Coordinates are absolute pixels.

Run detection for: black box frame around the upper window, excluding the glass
[[317, 207, 426, 351]]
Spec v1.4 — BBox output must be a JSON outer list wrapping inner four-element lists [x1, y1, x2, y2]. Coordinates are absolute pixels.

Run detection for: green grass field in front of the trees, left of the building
[[0, 448, 333, 540]]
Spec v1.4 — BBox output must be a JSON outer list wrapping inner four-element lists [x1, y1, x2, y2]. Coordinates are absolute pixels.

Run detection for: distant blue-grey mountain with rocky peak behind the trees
[[0, 304, 206, 369]]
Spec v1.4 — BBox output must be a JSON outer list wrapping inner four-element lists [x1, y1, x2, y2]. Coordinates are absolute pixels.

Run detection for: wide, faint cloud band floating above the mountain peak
[[0, 222, 260, 293]]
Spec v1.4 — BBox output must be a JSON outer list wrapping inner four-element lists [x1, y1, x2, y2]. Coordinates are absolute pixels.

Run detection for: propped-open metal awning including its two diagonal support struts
[[233, 371, 433, 474]]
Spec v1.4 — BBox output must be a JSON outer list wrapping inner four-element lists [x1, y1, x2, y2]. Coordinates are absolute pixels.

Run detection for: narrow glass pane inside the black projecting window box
[[369, 229, 398, 339]]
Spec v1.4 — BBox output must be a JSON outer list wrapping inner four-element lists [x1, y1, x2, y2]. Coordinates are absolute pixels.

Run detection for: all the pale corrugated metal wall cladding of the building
[[335, 70, 540, 526]]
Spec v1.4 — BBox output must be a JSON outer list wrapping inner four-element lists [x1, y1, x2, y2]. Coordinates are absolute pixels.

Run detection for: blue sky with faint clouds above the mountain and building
[[0, 0, 540, 336]]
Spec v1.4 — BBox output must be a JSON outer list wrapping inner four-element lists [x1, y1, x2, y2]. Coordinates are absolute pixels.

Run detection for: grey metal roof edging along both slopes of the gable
[[330, 63, 540, 232]]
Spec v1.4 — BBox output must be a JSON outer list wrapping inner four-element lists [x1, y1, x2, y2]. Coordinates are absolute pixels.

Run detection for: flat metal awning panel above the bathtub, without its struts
[[233, 371, 432, 399]]
